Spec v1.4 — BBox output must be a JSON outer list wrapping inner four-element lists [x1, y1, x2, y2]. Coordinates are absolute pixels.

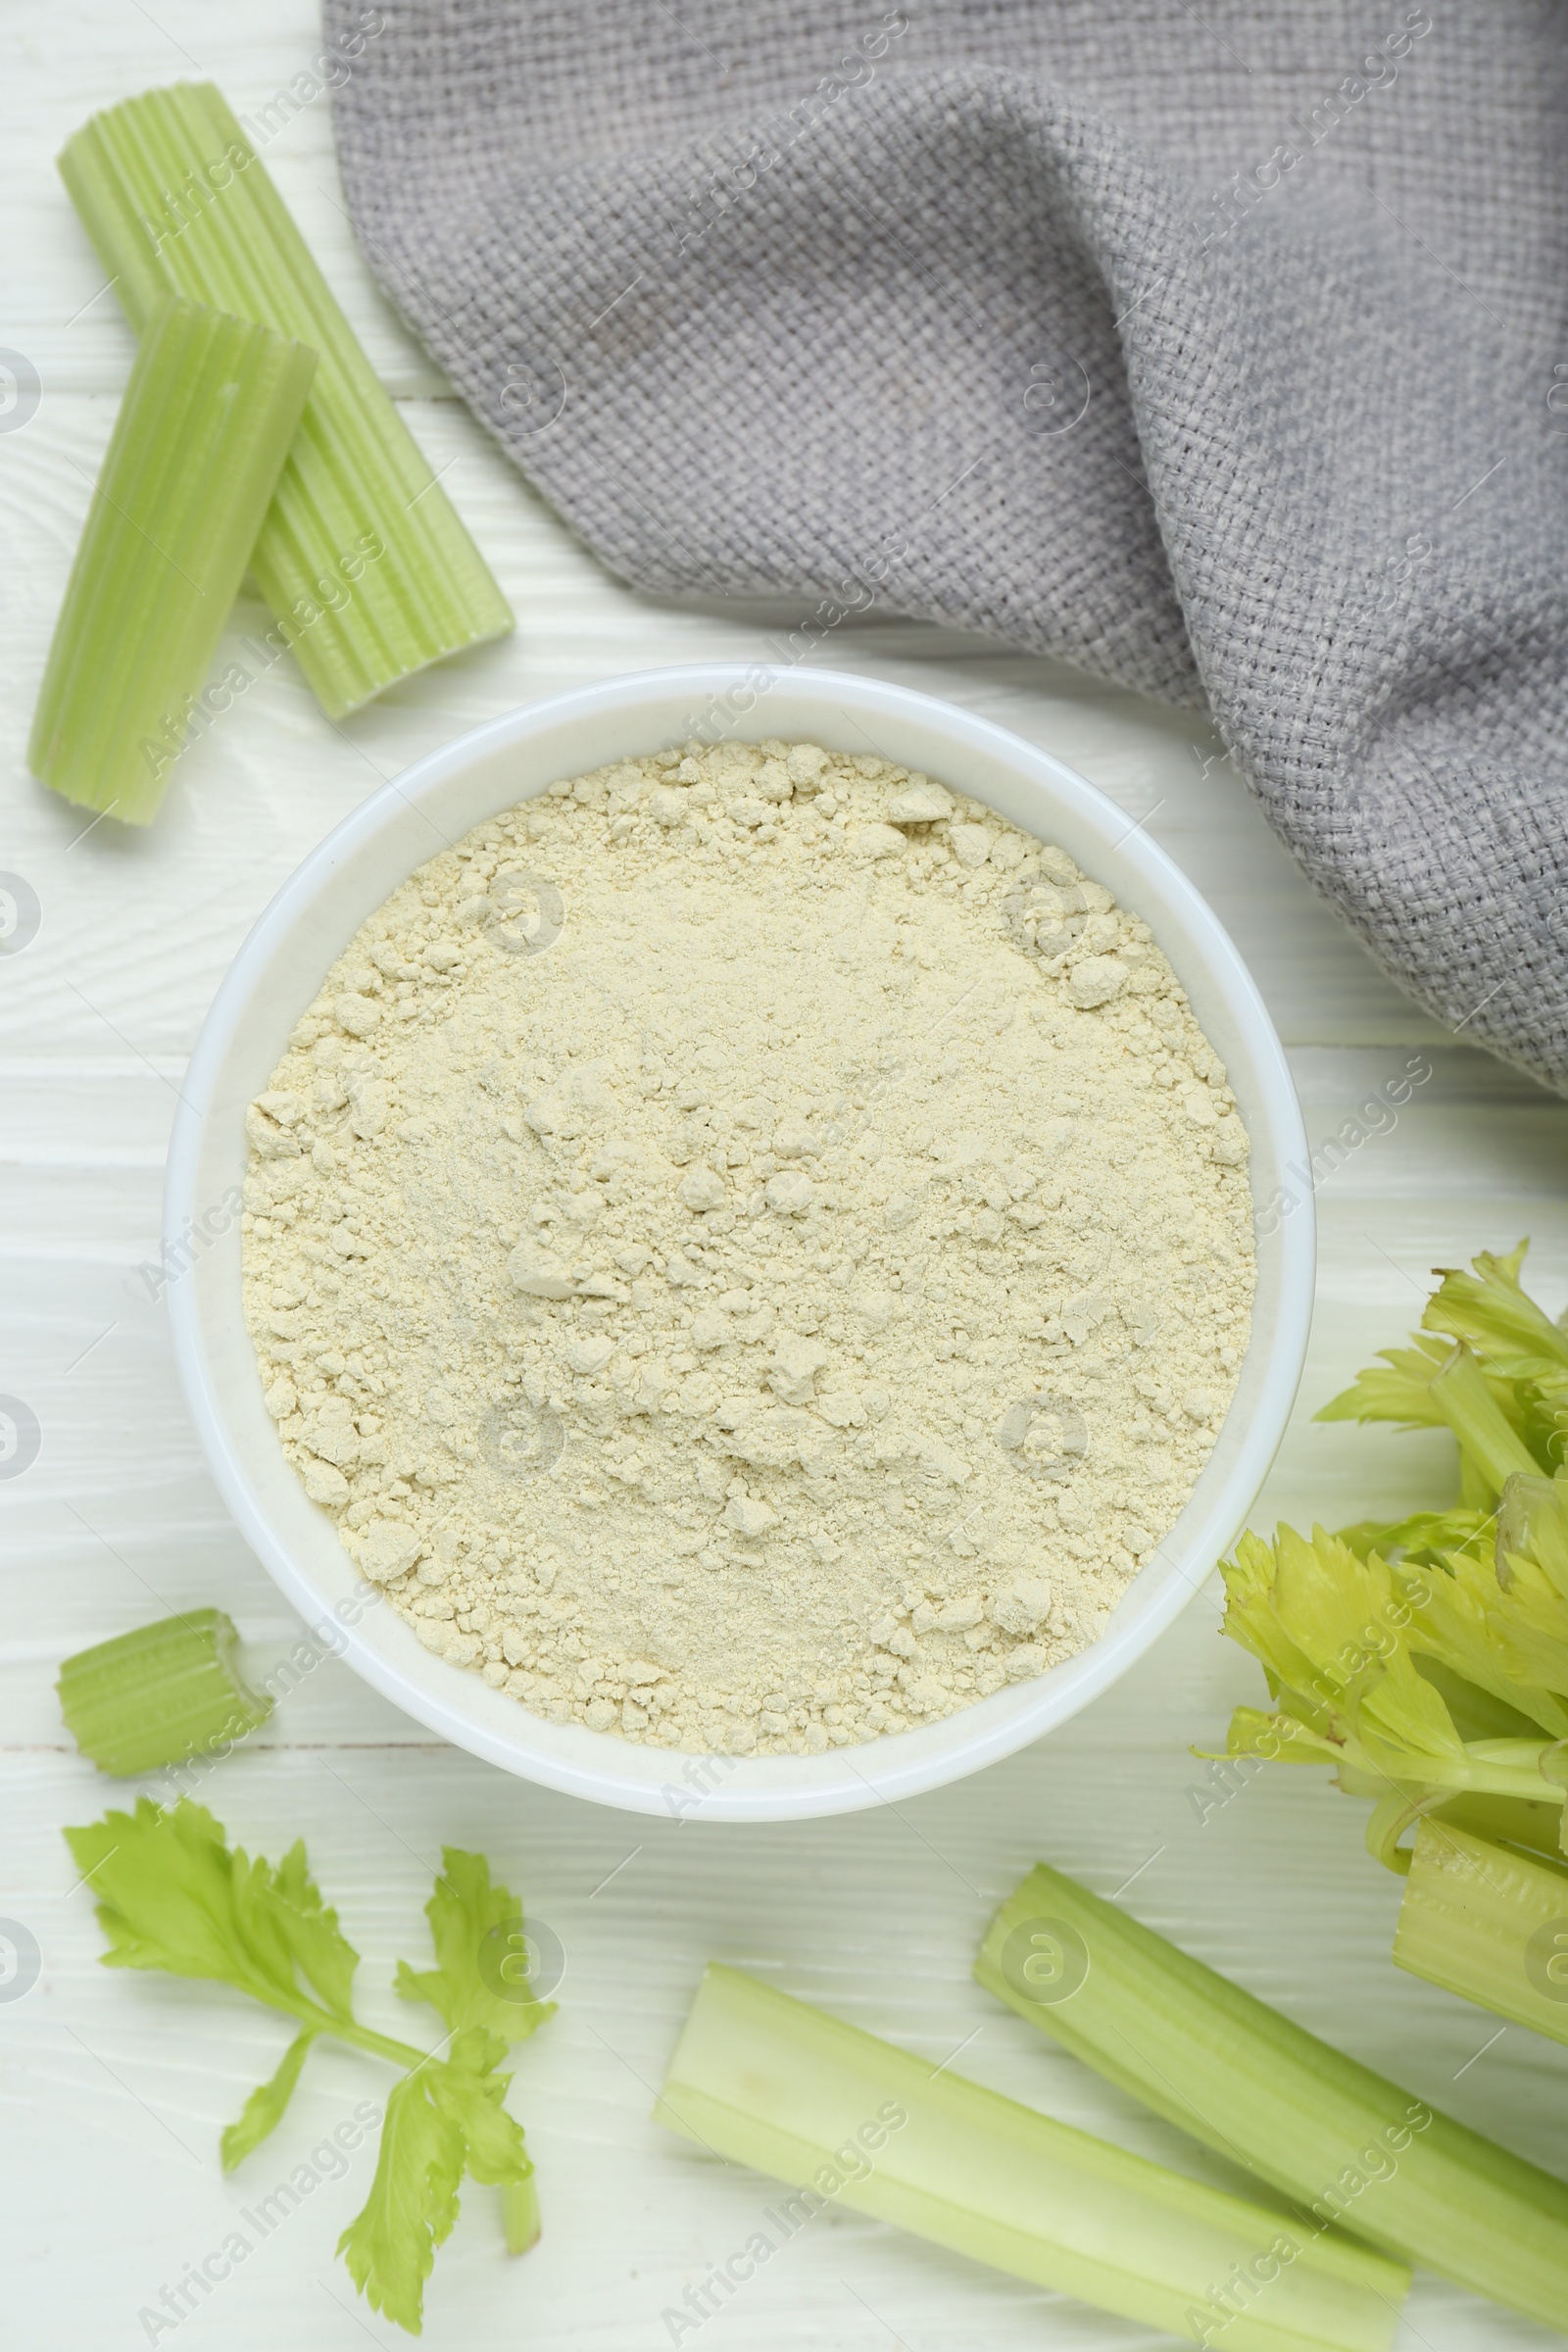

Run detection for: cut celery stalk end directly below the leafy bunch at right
[[1394, 1821, 1568, 2041]]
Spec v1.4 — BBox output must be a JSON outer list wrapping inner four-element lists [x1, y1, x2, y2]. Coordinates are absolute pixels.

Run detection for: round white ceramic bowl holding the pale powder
[[165, 665, 1314, 1821]]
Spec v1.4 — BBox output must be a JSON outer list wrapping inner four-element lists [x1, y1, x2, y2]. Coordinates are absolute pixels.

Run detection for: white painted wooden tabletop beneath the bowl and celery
[[0, 0, 1568, 2352]]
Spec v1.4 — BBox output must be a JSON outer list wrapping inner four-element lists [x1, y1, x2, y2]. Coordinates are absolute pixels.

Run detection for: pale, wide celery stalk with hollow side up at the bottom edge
[[654, 1966, 1408, 2352]]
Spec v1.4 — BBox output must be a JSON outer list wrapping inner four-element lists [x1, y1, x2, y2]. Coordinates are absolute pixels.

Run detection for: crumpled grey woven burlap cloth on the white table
[[326, 0, 1568, 1089]]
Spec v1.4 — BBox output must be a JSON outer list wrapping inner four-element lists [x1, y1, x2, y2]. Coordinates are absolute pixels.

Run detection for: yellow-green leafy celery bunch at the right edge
[[1225, 1242, 1568, 1870]]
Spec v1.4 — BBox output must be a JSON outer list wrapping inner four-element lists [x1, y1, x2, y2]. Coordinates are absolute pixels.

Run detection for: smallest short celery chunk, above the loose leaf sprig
[[57, 1609, 272, 1774]]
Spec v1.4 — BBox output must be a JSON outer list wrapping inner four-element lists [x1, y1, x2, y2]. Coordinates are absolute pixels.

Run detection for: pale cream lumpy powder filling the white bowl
[[242, 741, 1253, 1754]]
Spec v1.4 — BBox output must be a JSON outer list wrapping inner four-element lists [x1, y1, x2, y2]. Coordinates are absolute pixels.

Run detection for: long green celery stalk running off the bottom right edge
[[976, 1863, 1568, 2327]]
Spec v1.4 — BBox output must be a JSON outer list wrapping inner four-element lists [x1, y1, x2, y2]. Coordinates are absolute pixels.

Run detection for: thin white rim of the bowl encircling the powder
[[165, 661, 1316, 1821]]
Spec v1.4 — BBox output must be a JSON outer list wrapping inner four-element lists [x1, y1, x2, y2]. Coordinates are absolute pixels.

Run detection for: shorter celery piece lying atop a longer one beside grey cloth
[[28, 294, 315, 825]]
